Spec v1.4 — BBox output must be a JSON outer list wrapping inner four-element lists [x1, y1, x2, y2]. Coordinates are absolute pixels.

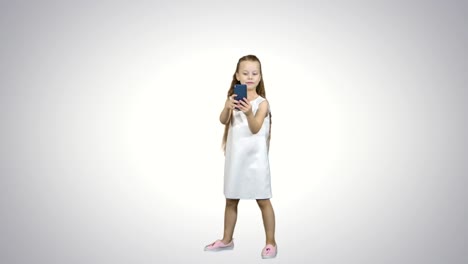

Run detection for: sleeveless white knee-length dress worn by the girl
[[224, 96, 271, 199]]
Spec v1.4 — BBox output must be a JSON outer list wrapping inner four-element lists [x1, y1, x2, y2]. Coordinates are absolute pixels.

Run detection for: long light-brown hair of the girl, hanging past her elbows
[[222, 55, 271, 152]]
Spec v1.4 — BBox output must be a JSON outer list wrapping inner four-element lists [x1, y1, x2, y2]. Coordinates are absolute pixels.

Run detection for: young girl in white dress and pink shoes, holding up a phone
[[205, 55, 277, 258]]
